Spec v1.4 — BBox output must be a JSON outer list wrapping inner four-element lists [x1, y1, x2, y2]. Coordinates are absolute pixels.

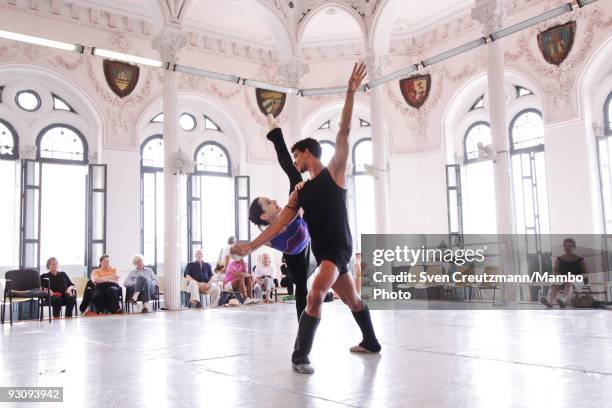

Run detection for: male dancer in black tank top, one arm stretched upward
[[232, 64, 381, 374]]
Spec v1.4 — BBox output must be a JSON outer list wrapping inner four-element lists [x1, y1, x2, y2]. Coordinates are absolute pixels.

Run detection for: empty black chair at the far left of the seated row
[[1, 269, 51, 325]]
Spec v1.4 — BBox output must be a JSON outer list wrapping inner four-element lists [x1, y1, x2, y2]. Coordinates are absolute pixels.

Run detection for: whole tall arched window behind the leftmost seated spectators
[[37, 124, 88, 274]]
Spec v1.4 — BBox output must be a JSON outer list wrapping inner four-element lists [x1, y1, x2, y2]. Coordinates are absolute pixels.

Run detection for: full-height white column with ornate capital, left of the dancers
[[153, 29, 187, 310]]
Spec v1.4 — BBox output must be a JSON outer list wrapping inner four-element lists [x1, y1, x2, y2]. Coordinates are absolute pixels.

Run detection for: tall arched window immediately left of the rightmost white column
[[462, 122, 497, 234]]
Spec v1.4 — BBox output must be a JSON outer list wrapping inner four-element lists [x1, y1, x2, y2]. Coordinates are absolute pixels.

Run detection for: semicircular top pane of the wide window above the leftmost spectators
[[36, 124, 87, 164]]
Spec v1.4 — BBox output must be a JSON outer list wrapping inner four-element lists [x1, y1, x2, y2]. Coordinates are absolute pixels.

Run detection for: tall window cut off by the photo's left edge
[[0, 119, 20, 270]]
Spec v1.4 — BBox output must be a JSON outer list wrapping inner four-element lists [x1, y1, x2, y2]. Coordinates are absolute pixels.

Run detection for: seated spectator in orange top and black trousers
[[91, 255, 121, 314]]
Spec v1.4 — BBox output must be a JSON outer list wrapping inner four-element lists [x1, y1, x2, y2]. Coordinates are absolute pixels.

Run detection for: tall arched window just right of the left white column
[[189, 142, 236, 263]]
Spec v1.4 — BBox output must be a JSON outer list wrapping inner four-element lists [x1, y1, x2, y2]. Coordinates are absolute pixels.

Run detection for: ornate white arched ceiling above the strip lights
[[0, 0, 556, 61]]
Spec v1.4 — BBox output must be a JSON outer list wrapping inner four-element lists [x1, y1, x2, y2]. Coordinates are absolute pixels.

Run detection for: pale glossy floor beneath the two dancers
[[0, 302, 612, 408]]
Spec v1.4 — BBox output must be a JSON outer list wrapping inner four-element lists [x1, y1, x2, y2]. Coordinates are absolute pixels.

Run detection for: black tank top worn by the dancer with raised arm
[[298, 167, 353, 257]]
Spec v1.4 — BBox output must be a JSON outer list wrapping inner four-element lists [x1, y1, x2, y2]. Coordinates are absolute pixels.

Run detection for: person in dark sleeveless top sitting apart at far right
[[540, 238, 588, 308]]
